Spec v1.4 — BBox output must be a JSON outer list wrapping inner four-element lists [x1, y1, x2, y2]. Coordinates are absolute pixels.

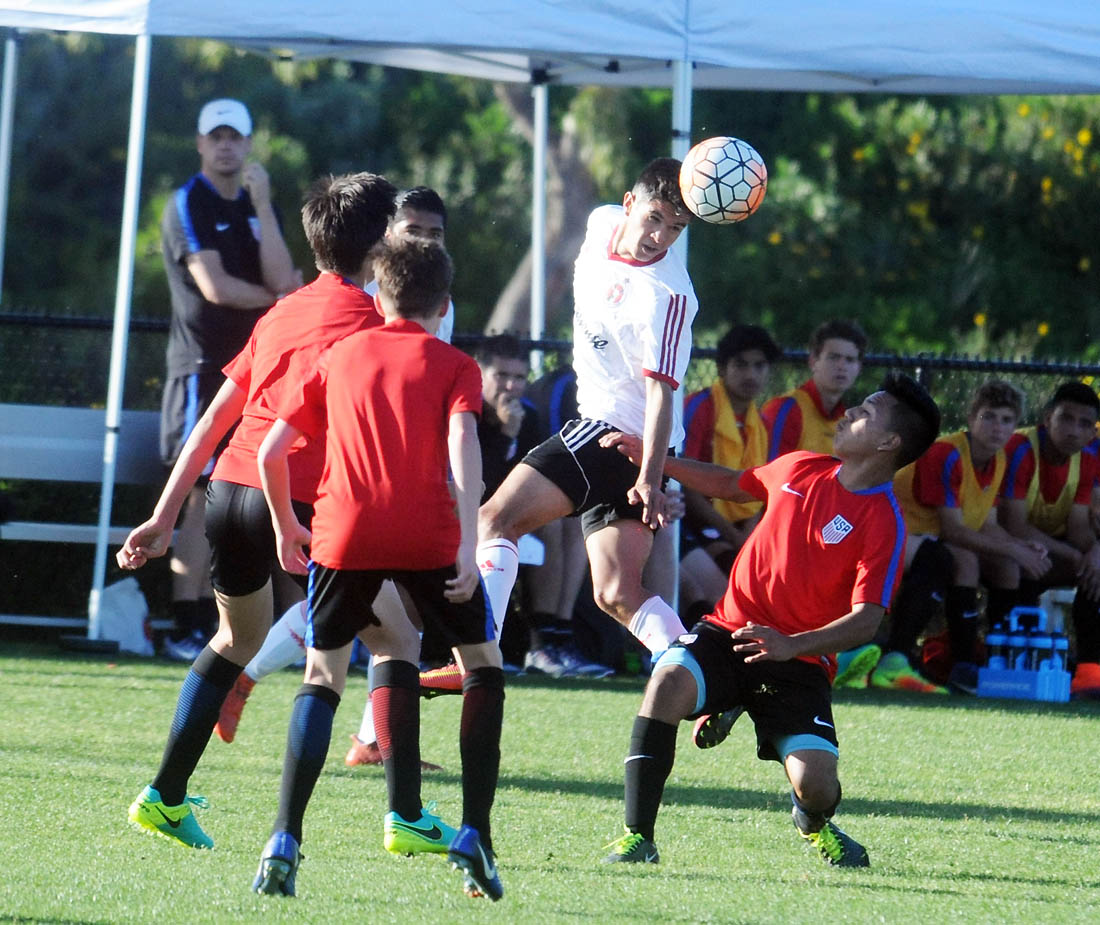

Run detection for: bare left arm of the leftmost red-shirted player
[[114, 379, 248, 569]]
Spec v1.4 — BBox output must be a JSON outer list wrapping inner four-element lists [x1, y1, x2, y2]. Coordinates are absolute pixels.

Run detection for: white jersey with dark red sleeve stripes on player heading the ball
[[573, 206, 699, 447]]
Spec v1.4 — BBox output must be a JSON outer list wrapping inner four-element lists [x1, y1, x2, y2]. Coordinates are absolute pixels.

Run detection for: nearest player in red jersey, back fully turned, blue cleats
[[253, 240, 504, 900]]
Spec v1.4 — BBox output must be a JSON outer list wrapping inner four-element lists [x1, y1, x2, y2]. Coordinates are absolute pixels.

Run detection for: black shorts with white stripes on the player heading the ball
[[524, 418, 671, 537]]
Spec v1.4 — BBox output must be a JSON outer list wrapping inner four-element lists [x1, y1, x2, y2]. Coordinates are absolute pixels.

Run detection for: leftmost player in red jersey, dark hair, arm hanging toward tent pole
[[117, 174, 396, 848]]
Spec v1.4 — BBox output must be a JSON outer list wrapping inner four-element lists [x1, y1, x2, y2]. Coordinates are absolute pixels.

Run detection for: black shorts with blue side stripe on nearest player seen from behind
[[306, 562, 496, 649]]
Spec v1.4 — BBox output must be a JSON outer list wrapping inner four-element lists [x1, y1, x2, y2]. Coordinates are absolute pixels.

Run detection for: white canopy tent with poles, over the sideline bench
[[0, 0, 1100, 638]]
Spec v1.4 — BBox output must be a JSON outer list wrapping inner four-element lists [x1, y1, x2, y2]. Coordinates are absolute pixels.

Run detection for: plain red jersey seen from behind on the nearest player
[[278, 320, 482, 570]]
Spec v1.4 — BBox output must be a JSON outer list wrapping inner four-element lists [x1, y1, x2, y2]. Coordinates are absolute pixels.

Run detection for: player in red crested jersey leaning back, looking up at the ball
[[605, 374, 939, 867]]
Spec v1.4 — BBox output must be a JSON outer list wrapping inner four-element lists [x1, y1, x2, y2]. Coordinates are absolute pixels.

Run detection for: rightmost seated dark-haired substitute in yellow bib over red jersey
[[1001, 382, 1100, 698]]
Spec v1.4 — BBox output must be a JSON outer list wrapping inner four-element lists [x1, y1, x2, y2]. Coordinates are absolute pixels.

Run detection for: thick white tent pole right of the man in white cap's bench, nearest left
[[88, 28, 152, 639]]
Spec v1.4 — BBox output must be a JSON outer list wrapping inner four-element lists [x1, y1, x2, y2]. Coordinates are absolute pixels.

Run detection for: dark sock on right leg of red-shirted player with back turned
[[459, 668, 504, 849]]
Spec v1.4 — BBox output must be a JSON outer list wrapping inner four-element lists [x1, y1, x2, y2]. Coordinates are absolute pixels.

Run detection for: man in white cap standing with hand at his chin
[[161, 99, 301, 661]]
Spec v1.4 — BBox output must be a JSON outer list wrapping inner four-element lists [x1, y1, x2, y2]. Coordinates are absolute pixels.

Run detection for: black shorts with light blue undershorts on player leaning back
[[670, 620, 837, 761]]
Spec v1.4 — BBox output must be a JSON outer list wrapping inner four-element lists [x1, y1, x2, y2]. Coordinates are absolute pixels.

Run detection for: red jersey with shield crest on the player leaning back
[[706, 451, 905, 678]]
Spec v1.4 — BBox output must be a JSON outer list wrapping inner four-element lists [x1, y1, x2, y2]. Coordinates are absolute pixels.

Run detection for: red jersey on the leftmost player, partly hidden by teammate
[[211, 273, 383, 504]]
